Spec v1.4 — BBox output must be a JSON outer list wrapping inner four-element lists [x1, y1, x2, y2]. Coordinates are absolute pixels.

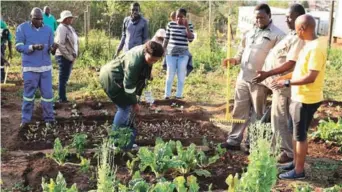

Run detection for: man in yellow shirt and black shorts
[[274, 15, 327, 179]]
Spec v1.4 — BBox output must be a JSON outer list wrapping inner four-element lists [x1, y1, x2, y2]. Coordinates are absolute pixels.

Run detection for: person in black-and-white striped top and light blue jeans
[[163, 8, 194, 99]]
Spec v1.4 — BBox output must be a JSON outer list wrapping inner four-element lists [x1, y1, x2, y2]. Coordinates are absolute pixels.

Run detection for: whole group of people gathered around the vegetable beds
[[1, 3, 327, 182]]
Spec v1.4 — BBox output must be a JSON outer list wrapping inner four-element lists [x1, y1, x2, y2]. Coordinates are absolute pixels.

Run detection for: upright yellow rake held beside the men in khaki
[[210, 14, 246, 123]]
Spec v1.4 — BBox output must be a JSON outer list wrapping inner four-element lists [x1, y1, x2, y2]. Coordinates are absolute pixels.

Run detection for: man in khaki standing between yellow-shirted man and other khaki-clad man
[[253, 4, 305, 163]]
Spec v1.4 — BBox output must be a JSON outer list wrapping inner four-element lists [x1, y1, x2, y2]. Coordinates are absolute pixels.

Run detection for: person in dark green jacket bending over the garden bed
[[100, 41, 164, 149]]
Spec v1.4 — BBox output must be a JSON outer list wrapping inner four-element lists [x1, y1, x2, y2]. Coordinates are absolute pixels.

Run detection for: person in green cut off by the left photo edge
[[0, 16, 12, 83]]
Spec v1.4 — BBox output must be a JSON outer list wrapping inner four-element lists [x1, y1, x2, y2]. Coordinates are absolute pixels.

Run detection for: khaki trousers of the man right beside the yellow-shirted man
[[271, 88, 293, 158]]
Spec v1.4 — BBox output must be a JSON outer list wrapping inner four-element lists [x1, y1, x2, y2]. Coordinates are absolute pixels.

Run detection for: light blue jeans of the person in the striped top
[[165, 55, 189, 97]]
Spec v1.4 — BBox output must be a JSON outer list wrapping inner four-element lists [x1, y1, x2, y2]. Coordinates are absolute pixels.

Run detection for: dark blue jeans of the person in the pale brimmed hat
[[56, 55, 73, 101]]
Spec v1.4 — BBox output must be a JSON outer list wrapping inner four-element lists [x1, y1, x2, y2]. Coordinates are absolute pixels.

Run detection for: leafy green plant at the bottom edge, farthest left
[[42, 172, 78, 192]]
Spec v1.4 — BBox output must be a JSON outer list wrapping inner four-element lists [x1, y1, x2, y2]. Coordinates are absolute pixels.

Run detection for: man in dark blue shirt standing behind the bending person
[[114, 3, 148, 57]]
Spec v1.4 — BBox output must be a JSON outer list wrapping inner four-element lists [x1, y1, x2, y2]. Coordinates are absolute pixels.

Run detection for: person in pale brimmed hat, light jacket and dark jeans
[[55, 10, 79, 103]]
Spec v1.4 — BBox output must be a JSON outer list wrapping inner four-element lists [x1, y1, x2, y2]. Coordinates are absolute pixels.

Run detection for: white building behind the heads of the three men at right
[[238, 6, 332, 36]]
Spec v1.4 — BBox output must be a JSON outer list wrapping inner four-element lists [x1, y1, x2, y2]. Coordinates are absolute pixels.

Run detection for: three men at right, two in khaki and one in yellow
[[221, 4, 327, 179]]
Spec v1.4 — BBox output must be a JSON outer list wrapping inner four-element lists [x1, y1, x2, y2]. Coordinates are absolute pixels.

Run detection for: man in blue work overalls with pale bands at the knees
[[15, 7, 56, 128]]
